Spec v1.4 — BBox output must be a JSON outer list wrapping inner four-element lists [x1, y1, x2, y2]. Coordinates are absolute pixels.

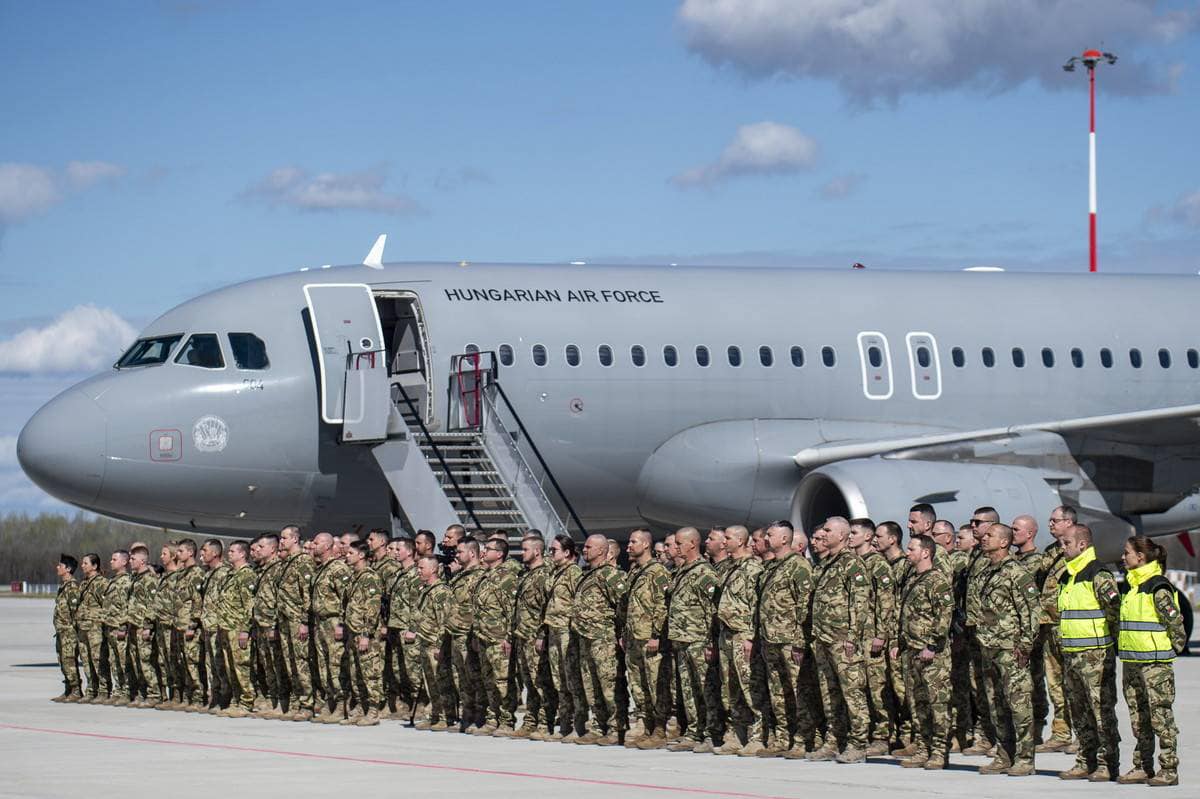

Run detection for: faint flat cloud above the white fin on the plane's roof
[[241, 167, 421, 215]]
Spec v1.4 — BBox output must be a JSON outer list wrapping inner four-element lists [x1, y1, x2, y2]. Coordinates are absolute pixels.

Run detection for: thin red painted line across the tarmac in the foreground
[[0, 723, 787, 799]]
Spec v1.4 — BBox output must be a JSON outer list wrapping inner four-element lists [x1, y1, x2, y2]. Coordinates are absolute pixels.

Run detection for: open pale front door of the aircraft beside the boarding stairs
[[304, 283, 391, 441]]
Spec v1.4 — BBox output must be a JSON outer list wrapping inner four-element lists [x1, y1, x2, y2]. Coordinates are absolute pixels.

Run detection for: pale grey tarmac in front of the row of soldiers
[[0, 599, 1200, 799]]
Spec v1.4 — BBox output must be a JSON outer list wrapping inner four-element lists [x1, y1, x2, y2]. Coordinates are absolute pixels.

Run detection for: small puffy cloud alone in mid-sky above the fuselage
[[671, 122, 817, 188]]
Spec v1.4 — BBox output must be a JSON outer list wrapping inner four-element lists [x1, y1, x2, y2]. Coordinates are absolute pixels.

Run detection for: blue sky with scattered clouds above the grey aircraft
[[0, 0, 1200, 511]]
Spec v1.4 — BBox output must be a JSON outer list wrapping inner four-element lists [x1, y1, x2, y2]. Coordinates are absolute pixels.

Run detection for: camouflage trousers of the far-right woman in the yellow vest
[[1121, 662, 1180, 774]]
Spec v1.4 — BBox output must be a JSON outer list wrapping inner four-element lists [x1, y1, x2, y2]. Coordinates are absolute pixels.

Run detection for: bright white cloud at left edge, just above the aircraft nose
[[0, 305, 137, 372]]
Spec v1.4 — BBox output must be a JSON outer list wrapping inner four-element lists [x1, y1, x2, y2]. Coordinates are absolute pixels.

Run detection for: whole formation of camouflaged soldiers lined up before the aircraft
[[54, 505, 1184, 786]]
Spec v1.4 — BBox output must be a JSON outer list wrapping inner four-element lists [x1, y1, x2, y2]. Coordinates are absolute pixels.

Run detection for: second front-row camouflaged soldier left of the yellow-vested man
[[890, 535, 954, 770]]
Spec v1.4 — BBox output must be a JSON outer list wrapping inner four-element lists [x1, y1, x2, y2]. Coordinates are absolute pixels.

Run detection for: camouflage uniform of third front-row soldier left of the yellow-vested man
[[812, 549, 871, 750]]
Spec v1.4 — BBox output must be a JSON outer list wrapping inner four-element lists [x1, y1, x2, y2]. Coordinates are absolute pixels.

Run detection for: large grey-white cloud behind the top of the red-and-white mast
[[678, 0, 1200, 103]]
